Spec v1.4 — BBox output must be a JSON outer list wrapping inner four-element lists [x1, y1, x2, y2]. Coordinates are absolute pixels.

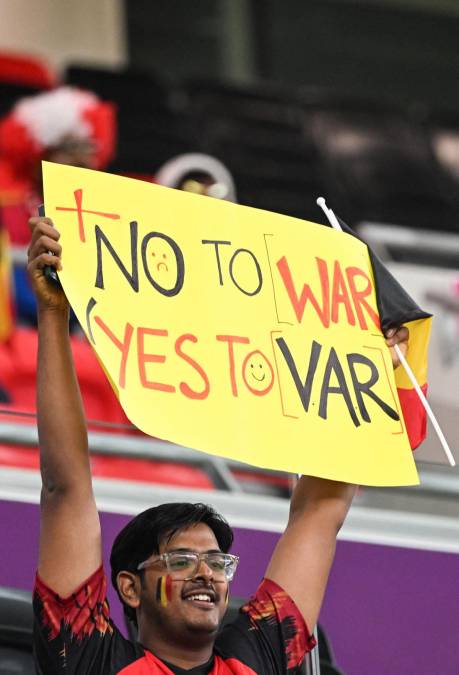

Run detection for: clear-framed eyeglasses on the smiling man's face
[[137, 551, 239, 581]]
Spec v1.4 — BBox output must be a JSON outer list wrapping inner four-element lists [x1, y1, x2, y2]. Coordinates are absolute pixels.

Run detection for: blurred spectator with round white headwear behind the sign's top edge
[[155, 152, 237, 202]]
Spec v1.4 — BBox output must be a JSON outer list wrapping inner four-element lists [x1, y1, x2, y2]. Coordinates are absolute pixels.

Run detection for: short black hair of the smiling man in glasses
[[110, 502, 233, 625]]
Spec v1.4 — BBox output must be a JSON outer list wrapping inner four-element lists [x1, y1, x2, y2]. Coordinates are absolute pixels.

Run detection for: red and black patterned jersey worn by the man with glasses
[[34, 567, 315, 675]]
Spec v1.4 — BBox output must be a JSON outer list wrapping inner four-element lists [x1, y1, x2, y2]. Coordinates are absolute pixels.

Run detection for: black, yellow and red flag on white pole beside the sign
[[338, 218, 432, 450]]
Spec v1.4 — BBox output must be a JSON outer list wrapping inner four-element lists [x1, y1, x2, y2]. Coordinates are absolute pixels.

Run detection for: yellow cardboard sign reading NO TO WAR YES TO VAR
[[43, 163, 418, 485]]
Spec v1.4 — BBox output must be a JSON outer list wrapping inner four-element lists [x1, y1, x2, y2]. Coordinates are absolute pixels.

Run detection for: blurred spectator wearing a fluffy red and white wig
[[0, 87, 116, 325]]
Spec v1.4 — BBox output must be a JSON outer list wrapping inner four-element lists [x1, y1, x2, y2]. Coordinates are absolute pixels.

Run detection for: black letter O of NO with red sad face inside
[[142, 232, 185, 296]]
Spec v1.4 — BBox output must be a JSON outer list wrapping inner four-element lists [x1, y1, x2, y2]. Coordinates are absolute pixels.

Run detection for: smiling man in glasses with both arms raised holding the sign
[[29, 218, 408, 675]]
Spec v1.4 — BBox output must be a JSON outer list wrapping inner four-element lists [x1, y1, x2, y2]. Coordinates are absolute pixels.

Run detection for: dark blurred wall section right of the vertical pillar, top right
[[256, 0, 459, 111]]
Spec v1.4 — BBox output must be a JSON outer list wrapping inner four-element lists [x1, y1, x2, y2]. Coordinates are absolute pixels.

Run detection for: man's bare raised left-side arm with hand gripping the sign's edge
[[28, 218, 101, 597]]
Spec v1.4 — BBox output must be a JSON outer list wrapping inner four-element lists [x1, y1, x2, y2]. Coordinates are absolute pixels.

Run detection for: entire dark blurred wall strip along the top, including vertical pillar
[[126, 0, 459, 110]]
